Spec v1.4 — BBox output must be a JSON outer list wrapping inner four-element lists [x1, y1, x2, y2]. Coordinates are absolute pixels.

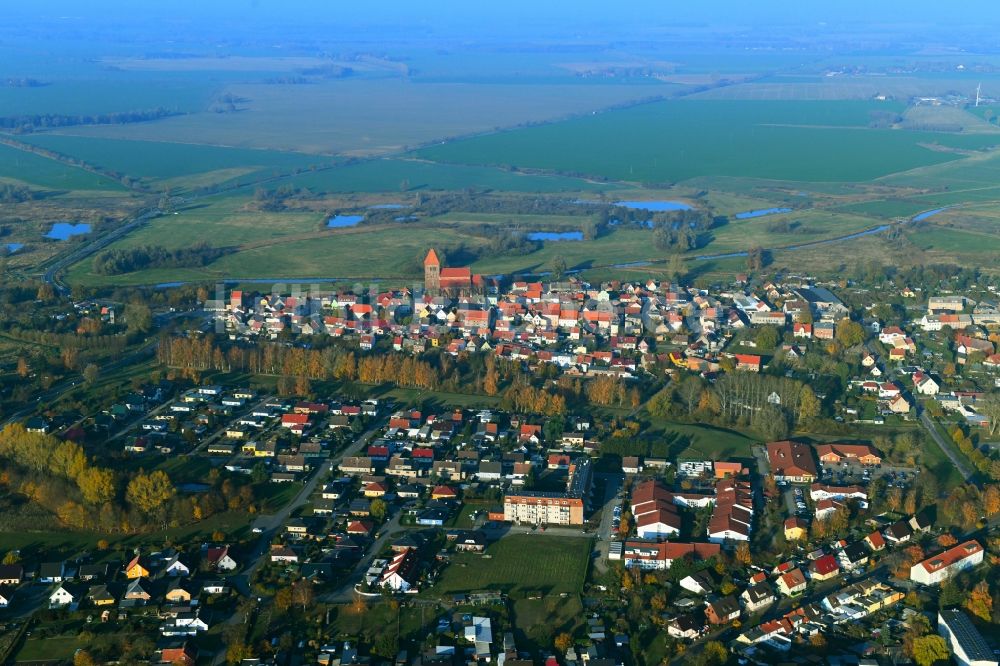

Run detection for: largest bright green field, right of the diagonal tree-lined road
[[417, 100, 1000, 183]]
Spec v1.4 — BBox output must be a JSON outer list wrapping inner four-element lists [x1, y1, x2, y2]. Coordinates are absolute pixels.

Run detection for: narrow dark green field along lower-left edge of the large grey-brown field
[[18, 134, 331, 188]]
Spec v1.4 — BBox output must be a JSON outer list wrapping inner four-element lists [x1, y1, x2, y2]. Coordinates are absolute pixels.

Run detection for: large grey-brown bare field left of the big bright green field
[[54, 77, 664, 155]]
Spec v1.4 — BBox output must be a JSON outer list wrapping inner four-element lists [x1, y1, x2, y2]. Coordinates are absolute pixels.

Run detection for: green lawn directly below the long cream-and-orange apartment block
[[430, 534, 592, 596]]
